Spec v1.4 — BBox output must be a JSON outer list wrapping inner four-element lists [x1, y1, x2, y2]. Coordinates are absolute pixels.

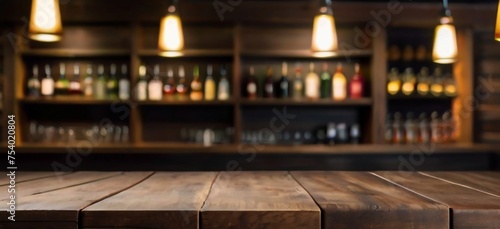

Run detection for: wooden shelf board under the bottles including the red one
[[240, 98, 373, 106]]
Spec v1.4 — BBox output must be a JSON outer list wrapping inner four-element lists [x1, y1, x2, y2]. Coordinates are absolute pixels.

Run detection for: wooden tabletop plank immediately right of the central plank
[[291, 171, 449, 229]]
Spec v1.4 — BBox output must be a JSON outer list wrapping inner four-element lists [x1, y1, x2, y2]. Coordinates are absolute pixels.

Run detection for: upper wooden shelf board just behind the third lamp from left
[[241, 49, 373, 59]]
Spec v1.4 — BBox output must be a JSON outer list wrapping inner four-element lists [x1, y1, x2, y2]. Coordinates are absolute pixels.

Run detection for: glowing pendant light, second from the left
[[158, 0, 184, 57]]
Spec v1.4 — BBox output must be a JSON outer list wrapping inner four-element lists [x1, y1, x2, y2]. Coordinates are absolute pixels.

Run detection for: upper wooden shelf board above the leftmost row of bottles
[[21, 49, 130, 57]]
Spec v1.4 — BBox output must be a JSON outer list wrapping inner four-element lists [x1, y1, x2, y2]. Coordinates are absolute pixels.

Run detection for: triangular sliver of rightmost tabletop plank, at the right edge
[[423, 172, 500, 196]]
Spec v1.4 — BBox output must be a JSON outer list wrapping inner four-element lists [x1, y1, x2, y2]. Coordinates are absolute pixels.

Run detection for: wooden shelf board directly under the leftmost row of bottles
[[18, 95, 128, 105]]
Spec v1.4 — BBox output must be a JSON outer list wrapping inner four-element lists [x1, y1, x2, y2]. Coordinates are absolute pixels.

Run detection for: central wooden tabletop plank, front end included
[[201, 172, 321, 229]]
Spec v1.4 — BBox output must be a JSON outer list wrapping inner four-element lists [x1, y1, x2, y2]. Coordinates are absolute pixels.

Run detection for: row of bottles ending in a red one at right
[[245, 62, 365, 100]]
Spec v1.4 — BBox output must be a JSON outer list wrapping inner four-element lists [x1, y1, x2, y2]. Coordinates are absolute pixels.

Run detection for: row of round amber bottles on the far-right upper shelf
[[387, 67, 457, 97]]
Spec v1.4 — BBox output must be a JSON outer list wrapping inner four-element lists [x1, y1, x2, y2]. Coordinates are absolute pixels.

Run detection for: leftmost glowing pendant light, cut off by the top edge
[[29, 0, 62, 42]]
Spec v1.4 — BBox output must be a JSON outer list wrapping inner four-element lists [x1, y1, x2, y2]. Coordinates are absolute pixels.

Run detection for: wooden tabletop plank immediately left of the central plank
[[82, 172, 217, 229]]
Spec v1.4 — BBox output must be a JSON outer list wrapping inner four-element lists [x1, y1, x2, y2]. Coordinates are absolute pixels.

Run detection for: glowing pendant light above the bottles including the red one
[[312, 0, 338, 57]]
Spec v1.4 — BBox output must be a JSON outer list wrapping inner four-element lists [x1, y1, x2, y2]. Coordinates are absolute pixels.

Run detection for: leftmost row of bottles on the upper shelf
[[27, 63, 130, 100]]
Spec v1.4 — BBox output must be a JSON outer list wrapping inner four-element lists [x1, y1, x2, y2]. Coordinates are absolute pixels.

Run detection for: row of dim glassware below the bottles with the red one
[[241, 122, 361, 145]]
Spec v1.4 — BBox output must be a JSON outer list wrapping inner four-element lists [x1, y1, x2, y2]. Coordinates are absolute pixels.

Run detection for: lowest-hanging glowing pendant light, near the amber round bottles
[[432, 0, 458, 64]]
